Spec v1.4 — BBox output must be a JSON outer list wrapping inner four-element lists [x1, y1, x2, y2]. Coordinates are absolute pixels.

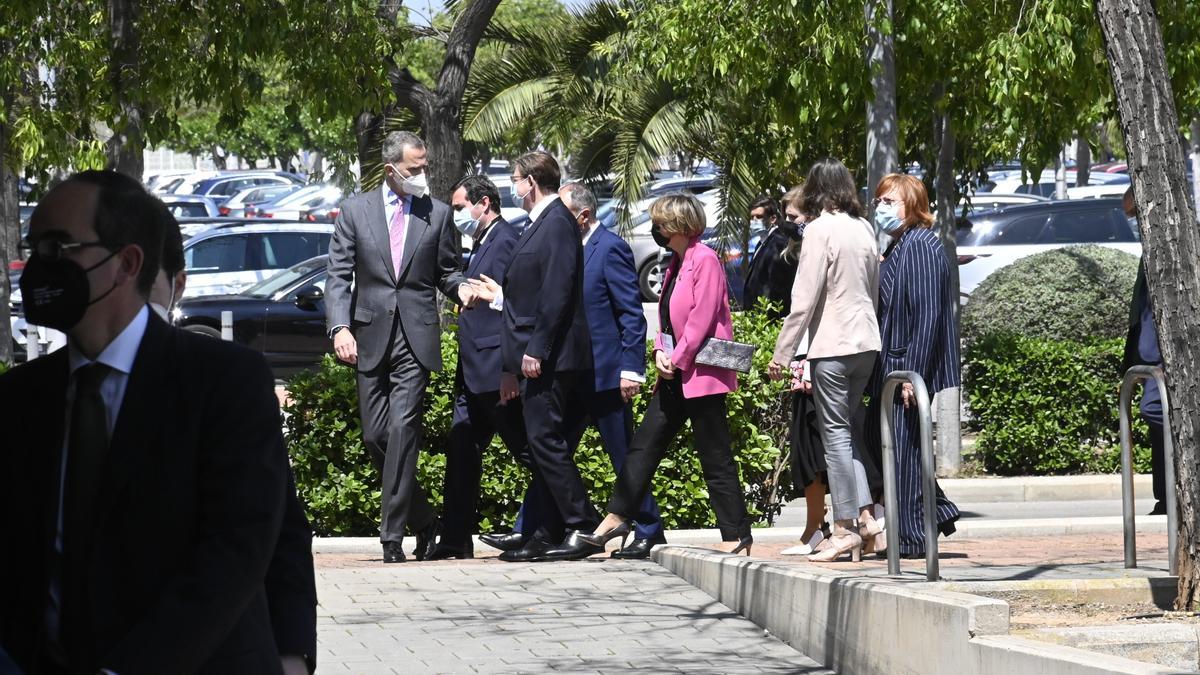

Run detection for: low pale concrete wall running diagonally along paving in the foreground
[[652, 545, 1182, 675]]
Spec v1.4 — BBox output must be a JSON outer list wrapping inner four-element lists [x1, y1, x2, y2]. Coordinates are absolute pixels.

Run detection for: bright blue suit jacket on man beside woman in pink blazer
[[583, 225, 646, 392]]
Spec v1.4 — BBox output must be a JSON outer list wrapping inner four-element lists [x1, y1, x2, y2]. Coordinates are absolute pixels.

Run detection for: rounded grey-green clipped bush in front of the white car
[[962, 244, 1138, 344]]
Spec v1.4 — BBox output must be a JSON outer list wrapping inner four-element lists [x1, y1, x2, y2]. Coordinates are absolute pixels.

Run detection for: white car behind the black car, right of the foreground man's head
[[184, 222, 334, 298]]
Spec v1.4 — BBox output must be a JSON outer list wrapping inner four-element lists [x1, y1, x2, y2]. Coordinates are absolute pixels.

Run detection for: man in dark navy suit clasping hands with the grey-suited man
[[465, 151, 604, 562]]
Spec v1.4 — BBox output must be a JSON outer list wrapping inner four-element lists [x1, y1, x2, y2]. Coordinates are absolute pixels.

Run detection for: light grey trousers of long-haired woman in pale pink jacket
[[809, 352, 878, 520]]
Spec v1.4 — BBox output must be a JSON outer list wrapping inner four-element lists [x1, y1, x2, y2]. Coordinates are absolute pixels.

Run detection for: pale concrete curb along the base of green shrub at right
[[937, 473, 1152, 503]]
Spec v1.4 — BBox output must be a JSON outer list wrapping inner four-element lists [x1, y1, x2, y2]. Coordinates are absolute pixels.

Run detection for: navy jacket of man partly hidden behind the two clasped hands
[[458, 217, 520, 394]]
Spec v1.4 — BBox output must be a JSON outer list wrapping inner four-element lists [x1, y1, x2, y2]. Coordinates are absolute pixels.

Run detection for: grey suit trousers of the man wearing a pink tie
[[358, 316, 437, 542]]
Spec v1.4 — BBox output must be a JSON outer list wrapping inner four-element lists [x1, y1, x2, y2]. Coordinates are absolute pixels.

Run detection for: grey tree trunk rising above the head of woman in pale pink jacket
[[865, 0, 900, 220]]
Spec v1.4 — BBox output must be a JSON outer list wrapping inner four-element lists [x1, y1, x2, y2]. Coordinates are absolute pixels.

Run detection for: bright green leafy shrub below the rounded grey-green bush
[[964, 334, 1150, 476]]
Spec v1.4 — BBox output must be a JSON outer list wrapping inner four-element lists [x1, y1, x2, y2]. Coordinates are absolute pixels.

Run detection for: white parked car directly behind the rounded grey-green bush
[[958, 199, 1141, 297]]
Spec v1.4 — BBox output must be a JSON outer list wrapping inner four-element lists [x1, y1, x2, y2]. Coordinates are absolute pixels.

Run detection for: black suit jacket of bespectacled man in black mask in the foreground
[[0, 313, 288, 675]]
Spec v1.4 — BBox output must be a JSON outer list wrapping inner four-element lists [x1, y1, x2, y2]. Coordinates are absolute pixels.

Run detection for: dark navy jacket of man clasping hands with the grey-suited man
[[500, 199, 592, 375]]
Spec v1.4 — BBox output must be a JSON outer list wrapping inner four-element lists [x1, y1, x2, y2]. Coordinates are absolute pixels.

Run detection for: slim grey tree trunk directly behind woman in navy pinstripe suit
[[936, 103, 962, 477]]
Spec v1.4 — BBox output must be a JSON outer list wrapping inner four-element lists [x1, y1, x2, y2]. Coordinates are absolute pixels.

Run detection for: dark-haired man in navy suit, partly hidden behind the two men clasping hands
[[428, 175, 533, 560]]
